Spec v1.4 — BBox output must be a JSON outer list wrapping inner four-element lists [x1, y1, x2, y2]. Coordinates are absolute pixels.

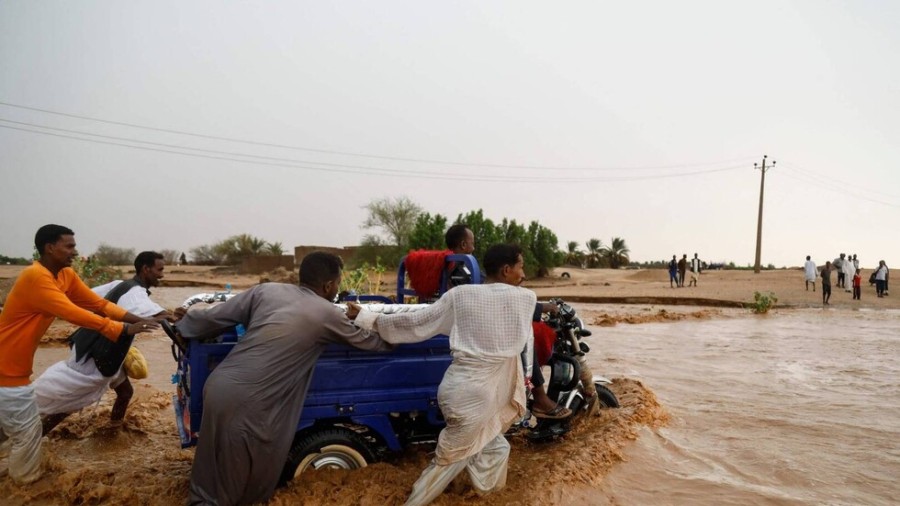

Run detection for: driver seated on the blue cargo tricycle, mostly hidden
[[444, 223, 572, 419]]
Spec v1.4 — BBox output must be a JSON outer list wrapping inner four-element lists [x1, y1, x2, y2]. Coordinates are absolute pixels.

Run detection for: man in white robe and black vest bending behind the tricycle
[[34, 251, 175, 434]]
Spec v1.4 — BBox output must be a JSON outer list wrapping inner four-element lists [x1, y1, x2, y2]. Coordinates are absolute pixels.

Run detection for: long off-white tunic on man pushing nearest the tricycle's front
[[356, 283, 537, 465]]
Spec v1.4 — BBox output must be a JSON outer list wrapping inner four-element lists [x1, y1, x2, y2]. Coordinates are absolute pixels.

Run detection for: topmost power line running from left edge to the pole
[[0, 101, 750, 171]]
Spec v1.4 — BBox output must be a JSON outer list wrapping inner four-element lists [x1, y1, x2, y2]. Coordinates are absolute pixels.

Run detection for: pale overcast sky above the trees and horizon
[[0, 0, 900, 267]]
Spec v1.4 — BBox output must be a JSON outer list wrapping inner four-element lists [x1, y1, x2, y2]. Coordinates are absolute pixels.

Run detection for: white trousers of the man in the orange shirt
[[0, 385, 42, 484]]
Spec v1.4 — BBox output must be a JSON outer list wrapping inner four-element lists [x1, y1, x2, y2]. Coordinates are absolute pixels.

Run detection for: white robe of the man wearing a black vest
[[33, 280, 165, 416]]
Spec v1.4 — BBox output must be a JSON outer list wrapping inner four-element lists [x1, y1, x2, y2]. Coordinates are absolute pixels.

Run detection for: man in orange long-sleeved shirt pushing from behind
[[0, 225, 159, 484]]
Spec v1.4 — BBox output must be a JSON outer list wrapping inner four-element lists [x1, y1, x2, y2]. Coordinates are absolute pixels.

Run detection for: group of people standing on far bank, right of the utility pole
[[803, 253, 890, 305]]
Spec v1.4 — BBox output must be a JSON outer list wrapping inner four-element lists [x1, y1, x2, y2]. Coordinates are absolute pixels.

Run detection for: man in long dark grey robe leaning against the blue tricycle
[[178, 252, 390, 506]]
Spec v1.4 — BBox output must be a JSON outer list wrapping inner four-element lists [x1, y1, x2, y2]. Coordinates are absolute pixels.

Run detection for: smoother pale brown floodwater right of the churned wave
[[585, 308, 900, 505]]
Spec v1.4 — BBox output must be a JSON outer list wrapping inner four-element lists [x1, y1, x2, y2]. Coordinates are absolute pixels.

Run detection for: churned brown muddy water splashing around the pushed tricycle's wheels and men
[[0, 378, 668, 506]]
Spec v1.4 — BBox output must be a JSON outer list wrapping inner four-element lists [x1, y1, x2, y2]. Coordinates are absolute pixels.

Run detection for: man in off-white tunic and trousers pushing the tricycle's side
[[348, 244, 536, 505]]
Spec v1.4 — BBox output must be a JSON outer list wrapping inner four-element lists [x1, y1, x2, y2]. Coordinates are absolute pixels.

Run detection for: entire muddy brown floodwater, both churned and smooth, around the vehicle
[[7, 298, 900, 506]]
